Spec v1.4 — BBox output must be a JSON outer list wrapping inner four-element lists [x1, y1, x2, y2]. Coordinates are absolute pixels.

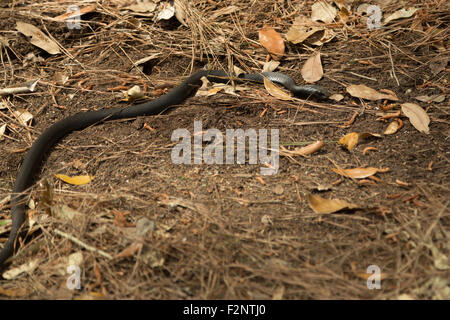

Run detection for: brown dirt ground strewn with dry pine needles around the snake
[[0, 0, 450, 299]]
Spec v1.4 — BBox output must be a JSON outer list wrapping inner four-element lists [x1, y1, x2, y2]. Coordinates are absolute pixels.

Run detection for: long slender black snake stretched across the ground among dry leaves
[[0, 70, 328, 267]]
